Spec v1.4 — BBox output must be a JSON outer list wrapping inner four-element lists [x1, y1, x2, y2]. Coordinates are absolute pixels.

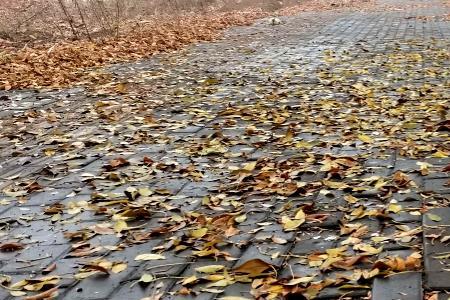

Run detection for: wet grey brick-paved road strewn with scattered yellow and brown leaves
[[0, 0, 450, 300]]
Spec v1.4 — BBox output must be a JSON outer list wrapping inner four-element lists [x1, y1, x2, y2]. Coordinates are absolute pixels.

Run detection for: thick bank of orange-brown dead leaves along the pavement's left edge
[[0, 10, 265, 90]]
